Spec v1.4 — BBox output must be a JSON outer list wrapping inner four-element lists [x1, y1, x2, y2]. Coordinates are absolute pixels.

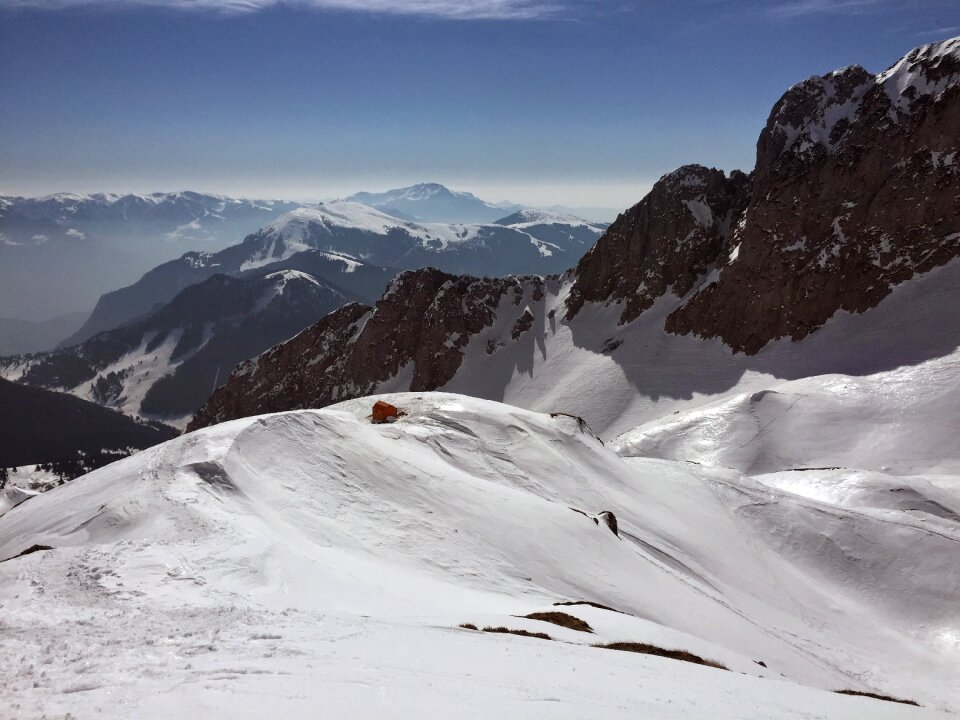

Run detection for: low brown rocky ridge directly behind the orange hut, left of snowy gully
[[182, 268, 543, 430]]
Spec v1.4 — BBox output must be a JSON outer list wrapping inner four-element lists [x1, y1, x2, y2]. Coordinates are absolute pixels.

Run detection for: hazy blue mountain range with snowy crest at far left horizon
[[0, 192, 297, 324]]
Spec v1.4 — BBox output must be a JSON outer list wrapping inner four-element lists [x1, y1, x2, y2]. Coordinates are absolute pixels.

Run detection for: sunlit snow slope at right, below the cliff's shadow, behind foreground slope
[[614, 354, 960, 475]]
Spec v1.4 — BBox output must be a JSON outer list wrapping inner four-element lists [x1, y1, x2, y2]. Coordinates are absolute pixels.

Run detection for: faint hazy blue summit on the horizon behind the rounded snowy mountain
[[347, 183, 520, 223]]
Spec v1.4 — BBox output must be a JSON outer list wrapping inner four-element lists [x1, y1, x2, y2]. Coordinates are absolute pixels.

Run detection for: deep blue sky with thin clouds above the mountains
[[0, 0, 960, 208]]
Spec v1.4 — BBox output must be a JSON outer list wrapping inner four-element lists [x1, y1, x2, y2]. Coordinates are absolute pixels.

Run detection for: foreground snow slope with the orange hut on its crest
[[0, 393, 960, 718]]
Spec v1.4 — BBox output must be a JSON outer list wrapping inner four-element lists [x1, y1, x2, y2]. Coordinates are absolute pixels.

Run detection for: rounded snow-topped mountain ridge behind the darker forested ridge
[[64, 201, 604, 345]]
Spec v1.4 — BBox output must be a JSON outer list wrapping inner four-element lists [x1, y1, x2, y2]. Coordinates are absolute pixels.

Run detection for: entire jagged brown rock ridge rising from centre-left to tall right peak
[[191, 38, 960, 427]]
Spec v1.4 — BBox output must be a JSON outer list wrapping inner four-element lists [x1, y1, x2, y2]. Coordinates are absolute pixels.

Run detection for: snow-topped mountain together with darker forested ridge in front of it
[[0, 188, 605, 423]]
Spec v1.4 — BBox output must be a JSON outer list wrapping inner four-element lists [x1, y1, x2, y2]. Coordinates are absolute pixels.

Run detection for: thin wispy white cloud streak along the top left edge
[[0, 0, 570, 20]]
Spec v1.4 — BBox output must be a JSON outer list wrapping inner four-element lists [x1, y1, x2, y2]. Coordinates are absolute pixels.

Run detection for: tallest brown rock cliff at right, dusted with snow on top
[[664, 38, 960, 353]]
